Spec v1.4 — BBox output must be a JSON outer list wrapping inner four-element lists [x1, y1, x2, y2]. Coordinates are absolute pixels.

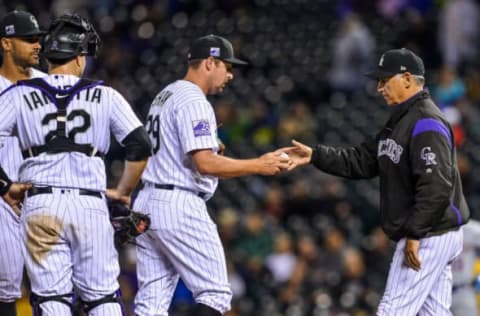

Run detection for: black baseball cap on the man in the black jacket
[[365, 48, 425, 80]]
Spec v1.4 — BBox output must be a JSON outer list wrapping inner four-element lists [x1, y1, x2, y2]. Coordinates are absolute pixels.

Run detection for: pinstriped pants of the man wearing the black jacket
[[377, 228, 463, 316]]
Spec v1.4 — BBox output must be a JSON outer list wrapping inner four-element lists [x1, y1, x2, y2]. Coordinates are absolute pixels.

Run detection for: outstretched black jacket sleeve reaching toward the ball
[[311, 139, 378, 179]]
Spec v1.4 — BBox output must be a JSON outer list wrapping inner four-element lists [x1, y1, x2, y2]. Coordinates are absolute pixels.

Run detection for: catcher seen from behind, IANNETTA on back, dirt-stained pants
[[0, 15, 150, 316]]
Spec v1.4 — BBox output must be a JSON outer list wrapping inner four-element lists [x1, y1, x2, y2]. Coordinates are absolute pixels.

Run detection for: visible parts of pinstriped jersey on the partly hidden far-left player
[[0, 68, 46, 181]]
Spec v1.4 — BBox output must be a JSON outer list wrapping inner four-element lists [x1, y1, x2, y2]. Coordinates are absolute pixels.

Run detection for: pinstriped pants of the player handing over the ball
[[134, 187, 232, 316]]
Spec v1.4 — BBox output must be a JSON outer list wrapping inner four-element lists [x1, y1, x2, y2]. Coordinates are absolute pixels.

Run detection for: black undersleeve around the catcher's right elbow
[[122, 126, 152, 161]]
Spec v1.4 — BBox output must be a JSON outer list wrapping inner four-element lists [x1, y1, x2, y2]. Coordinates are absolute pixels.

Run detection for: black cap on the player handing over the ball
[[188, 34, 248, 65]]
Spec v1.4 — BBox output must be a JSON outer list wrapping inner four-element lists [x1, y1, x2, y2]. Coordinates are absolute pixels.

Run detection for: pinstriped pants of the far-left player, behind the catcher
[[0, 199, 24, 302]]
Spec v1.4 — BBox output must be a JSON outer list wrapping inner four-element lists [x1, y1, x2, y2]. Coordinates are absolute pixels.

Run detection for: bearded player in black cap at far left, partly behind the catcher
[[0, 11, 45, 316]]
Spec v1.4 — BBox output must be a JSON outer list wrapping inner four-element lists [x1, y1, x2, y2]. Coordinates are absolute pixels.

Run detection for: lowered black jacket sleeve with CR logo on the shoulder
[[406, 121, 455, 239]]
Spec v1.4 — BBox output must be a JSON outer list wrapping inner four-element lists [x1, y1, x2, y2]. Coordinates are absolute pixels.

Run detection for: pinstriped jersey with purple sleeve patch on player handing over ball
[[142, 80, 218, 196]]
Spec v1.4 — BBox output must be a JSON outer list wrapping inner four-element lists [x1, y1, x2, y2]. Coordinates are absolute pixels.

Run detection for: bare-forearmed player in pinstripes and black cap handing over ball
[[130, 35, 290, 316]]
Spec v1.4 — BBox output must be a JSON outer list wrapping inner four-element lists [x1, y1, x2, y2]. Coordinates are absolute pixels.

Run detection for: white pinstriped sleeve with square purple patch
[[176, 101, 218, 154]]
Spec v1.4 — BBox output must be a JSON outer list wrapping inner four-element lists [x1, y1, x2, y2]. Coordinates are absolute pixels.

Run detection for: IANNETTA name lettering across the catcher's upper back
[[23, 86, 102, 111]]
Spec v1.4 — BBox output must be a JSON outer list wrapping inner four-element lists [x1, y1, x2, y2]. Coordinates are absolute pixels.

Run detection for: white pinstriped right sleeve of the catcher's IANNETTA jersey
[[110, 88, 143, 143]]
